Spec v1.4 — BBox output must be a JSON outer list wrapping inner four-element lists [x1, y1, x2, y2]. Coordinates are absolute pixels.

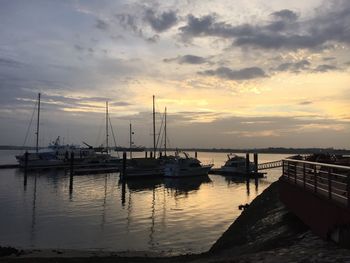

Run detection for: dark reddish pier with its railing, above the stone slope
[[279, 159, 350, 247]]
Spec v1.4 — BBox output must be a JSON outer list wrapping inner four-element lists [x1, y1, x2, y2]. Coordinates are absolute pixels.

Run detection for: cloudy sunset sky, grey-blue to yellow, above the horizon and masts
[[0, 0, 350, 149]]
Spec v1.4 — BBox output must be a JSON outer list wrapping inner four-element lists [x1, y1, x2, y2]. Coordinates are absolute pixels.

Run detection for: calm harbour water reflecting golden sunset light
[[0, 151, 286, 254]]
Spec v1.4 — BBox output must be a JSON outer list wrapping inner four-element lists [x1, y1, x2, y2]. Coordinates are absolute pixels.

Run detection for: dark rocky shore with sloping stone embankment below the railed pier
[[0, 182, 350, 262]]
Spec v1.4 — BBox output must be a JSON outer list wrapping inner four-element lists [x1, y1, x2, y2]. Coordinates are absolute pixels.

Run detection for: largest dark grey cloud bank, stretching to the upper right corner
[[179, 0, 350, 50]]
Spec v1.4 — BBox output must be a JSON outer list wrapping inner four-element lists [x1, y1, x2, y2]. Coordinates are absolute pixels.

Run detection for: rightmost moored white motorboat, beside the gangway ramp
[[211, 154, 264, 177]]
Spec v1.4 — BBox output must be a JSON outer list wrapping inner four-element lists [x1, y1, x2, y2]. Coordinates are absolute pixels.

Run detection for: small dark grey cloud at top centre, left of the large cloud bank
[[144, 9, 178, 33]]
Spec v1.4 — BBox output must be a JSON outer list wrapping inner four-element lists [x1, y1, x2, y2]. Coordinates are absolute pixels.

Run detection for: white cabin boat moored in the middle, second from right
[[164, 152, 213, 177]]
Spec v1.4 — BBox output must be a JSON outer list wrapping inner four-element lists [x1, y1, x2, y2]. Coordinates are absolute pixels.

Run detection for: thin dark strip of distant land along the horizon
[[0, 145, 350, 155]]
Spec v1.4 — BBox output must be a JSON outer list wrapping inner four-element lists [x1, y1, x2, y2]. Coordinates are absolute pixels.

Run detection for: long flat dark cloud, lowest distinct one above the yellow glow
[[198, 67, 267, 80]]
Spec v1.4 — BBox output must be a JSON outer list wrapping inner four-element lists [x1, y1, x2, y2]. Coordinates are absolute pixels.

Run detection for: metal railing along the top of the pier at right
[[282, 159, 350, 208]]
